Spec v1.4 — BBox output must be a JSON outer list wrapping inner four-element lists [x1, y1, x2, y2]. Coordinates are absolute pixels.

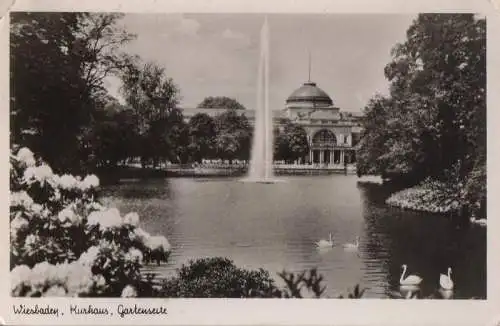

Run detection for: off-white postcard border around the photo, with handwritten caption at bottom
[[0, 0, 500, 326]]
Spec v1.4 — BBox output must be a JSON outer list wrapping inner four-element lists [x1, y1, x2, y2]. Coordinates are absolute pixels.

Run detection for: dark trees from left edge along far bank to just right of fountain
[[10, 13, 308, 173]]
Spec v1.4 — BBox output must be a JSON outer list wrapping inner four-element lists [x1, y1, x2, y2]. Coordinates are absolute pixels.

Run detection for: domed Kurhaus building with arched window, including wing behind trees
[[183, 81, 362, 167]]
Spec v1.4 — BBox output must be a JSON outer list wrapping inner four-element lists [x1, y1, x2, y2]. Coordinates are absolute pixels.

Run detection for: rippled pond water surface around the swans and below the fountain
[[99, 175, 487, 299]]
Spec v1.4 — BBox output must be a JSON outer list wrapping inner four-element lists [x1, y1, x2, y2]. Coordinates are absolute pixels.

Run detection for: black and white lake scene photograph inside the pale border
[[6, 0, 490, 320]]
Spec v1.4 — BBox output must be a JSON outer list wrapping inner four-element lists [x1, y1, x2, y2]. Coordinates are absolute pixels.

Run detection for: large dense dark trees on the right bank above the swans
[[357, 14, 486, 214]]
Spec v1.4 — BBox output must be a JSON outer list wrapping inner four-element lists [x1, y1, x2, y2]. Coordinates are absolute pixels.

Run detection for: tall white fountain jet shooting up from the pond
[[244, 18, 277, 183]]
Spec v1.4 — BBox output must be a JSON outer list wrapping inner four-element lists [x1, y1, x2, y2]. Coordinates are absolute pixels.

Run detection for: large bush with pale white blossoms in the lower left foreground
[[10, 148, 170, 297]]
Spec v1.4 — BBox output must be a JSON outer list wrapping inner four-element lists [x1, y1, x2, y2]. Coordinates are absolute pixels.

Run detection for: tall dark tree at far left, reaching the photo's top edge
[[10, 13, 133, 171]]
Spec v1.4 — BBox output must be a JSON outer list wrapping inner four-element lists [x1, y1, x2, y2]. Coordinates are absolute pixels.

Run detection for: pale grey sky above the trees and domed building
[[107, 14, 415, 111]]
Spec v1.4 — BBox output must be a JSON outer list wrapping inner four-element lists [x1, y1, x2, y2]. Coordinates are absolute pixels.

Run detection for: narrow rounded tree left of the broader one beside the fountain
[[188, 113, 217, 163]]
